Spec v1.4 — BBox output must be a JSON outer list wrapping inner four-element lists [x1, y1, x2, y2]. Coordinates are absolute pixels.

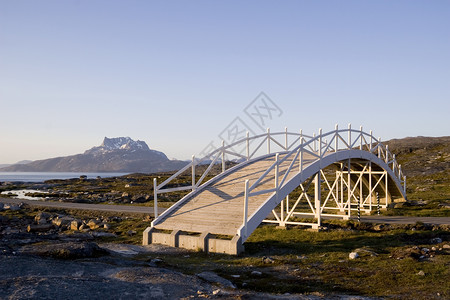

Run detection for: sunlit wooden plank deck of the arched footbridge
[[155, 155, 314, 236]]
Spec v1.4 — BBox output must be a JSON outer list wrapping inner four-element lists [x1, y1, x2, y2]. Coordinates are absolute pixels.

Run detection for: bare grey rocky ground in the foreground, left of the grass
[[0, 204, 386, 299]]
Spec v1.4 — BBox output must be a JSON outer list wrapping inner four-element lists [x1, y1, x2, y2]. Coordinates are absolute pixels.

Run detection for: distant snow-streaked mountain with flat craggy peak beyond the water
[[0, 137, 186, 173]]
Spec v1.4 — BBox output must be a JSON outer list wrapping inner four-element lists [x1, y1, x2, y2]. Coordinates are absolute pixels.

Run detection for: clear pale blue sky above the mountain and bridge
[[0, 0, 450, 163]]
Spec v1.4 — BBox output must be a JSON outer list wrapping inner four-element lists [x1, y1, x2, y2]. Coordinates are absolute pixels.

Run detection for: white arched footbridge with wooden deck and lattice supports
[[143, 125, 406, 254]]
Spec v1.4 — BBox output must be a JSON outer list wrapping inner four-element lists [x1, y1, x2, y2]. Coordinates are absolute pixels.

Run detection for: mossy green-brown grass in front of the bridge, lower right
[[141, 226, 450, 299]]
